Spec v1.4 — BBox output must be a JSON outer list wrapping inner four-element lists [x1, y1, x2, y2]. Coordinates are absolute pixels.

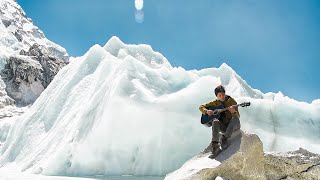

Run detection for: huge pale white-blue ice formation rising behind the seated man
[[0, 37, 320, 176]]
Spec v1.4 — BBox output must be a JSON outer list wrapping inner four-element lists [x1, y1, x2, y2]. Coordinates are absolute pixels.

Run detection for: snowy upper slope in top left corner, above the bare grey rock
[[0, 0, 68, 59]]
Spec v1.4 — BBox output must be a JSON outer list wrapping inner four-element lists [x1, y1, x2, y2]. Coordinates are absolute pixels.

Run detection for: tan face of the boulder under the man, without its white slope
[[194, 133, 266, 180]]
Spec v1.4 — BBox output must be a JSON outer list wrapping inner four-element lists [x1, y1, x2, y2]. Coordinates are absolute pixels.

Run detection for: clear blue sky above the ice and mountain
[[17, 0, 320, 102]]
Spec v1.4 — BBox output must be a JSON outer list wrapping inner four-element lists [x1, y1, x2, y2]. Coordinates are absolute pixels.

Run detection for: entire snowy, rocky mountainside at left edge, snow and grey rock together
[[0, 0, 69, 105]]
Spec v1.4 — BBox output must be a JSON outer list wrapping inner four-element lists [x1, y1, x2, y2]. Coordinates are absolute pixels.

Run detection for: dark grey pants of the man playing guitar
[[212, 117, 240, 142]]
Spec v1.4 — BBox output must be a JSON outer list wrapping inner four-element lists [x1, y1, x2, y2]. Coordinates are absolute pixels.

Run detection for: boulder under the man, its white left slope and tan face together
[[165, 132, 266, 180]]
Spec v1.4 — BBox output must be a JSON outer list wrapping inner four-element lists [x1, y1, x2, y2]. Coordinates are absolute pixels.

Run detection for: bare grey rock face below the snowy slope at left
[[1, 44, 67, 105]]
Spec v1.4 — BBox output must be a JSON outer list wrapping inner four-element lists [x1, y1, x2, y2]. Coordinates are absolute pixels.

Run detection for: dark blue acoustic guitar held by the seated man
[[201, 102, 251, 127]]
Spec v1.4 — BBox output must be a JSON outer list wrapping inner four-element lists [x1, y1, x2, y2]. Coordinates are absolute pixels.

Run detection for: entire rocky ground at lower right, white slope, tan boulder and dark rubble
[[165, 132, 320, 180]]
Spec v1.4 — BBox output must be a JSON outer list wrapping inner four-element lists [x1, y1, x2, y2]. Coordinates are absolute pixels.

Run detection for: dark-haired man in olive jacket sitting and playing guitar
[[199, 85, 240, 158]]
